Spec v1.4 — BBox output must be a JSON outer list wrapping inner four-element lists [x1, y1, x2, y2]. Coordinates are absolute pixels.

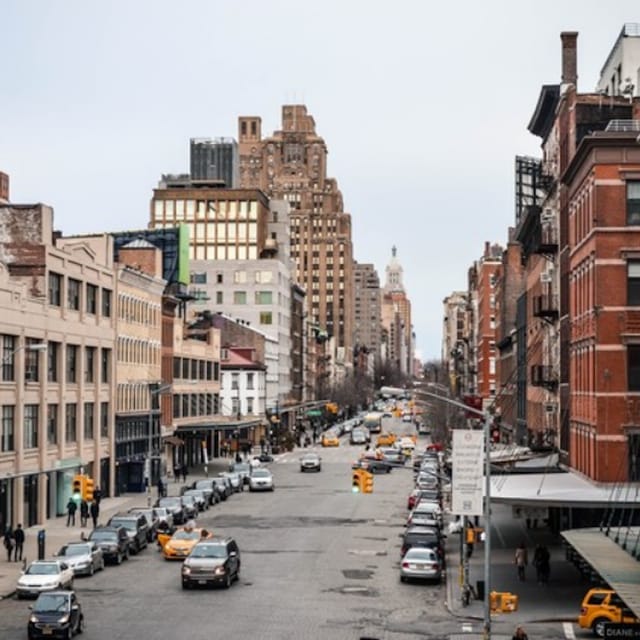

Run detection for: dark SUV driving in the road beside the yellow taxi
[[182, 537, 240, 589]]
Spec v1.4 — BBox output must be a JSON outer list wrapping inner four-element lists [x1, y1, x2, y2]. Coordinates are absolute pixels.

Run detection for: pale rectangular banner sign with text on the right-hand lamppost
[[451, 429, 484, 516]]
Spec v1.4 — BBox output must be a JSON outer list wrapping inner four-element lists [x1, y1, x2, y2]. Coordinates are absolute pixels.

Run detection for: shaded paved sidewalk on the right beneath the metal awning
[[447, 505, 589, 623]]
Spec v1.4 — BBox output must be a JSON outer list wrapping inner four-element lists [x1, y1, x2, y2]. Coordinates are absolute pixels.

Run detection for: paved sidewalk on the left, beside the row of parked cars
[[0, 458, 232, 599]]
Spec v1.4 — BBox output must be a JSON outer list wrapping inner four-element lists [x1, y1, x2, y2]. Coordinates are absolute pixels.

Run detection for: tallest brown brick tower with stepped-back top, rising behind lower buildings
[[239, 105, 353, 378]]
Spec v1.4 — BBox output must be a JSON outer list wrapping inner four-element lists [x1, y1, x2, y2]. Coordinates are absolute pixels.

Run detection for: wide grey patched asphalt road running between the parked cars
[[0, 420, 596, 640]]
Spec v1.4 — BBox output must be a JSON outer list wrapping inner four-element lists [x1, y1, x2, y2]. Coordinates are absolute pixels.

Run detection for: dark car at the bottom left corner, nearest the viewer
[[27, 591, 84, 640]]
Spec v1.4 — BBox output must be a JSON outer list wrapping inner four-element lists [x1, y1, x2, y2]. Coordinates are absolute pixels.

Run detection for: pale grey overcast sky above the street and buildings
[[0, 0, 640, 359]]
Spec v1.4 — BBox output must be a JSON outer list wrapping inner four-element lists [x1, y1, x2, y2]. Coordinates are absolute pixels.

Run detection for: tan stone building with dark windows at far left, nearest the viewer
[[0, 204, 116, 526]]
